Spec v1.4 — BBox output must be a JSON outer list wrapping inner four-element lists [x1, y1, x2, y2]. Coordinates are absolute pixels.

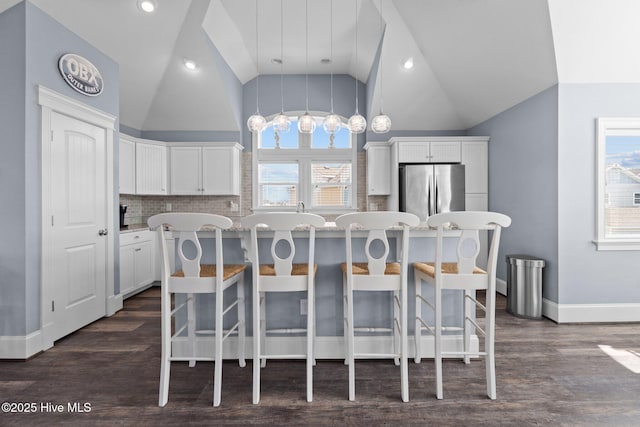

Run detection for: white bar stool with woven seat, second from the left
[[242, 212, 324, 404]]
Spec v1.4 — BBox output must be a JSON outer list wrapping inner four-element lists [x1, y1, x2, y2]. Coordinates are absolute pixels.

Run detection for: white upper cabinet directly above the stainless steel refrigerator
[[391, 138, 461, 163]]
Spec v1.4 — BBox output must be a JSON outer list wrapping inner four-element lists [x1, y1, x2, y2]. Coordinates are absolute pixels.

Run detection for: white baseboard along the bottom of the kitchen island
[[173, 335, 479, 360]]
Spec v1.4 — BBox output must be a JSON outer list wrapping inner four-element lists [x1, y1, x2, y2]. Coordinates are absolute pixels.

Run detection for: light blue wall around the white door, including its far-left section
[[0, 2, 119, 336]]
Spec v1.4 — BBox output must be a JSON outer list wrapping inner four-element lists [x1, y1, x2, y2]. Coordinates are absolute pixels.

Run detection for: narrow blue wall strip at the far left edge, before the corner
[[0, 3, 27, 336]]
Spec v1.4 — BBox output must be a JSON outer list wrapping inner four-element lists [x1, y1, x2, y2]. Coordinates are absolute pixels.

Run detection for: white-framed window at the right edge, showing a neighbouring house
[[596, 118, 640, 250]]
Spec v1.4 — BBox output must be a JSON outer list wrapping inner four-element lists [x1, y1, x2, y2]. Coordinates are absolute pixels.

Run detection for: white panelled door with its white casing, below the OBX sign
[[39, 87, 117, 350]]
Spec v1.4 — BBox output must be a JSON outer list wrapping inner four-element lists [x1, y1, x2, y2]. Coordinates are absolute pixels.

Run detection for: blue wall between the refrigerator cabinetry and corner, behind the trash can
[[468, 86, 560, 302]]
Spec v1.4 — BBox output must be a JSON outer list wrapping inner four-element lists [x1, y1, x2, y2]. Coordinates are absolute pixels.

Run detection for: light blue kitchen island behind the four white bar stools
[[162, 222, 477, 359]]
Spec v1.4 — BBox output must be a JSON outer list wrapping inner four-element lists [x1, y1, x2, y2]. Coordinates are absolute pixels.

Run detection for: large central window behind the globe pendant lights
[[253, 117, 357, 213]]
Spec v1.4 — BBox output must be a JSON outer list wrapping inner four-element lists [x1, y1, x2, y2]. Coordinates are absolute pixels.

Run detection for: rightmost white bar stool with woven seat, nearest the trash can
[[413, 211, 511, 399]]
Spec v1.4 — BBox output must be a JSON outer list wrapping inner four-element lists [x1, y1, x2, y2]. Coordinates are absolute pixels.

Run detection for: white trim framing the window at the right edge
[[594, 117, 640, 251]]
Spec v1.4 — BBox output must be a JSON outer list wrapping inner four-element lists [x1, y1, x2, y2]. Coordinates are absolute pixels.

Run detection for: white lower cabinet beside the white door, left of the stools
[[120, 230, 158, 298]]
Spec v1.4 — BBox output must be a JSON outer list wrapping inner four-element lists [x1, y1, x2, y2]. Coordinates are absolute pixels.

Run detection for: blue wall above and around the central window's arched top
[[241, 75, 367, 151]]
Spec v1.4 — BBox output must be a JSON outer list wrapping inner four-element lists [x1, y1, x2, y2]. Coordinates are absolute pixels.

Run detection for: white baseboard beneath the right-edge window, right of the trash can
[[542, 299, 640, 323]]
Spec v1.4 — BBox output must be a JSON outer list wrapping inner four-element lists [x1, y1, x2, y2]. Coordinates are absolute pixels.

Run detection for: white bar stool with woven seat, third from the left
[[336, 212, 420, 402]]
